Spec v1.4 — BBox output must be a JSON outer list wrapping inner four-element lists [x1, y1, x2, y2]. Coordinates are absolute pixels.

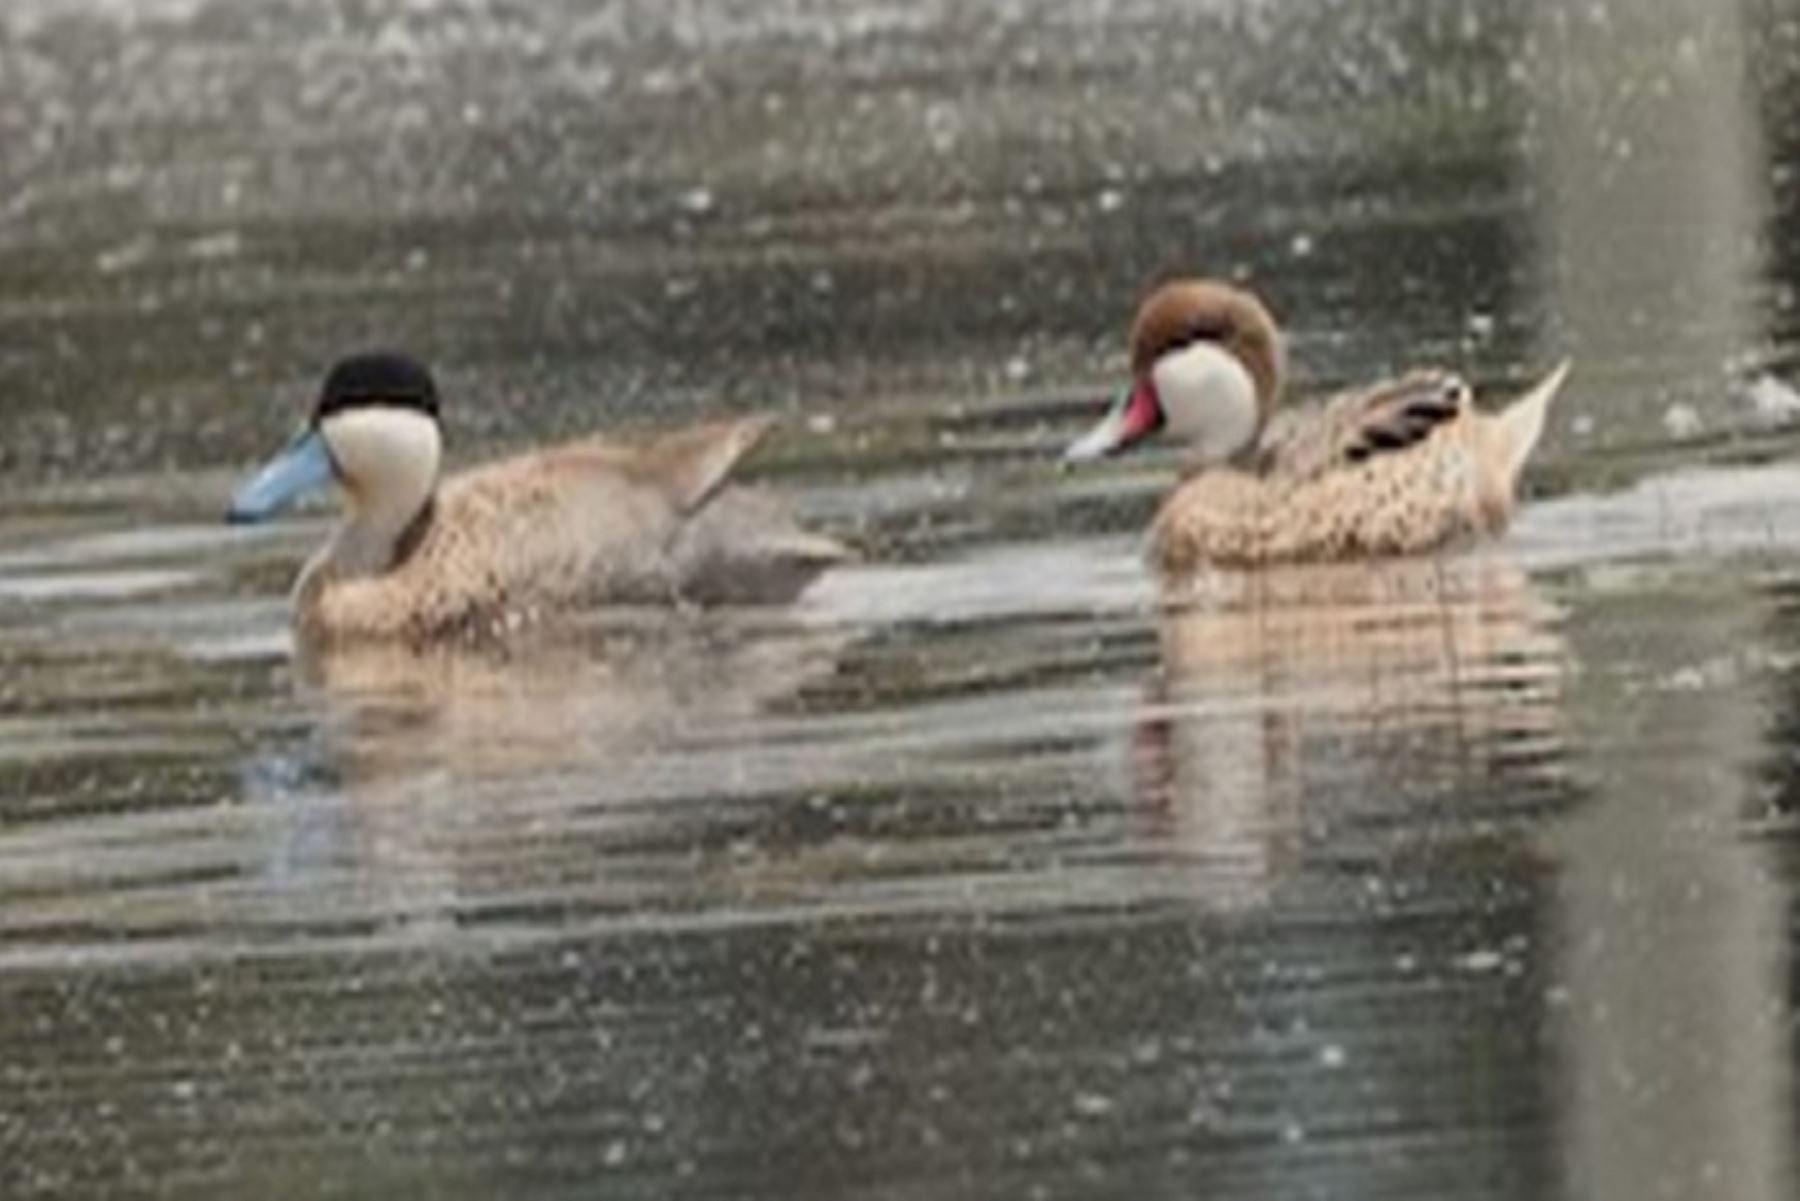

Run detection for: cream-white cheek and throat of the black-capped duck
[[319, 405, 443, 574]]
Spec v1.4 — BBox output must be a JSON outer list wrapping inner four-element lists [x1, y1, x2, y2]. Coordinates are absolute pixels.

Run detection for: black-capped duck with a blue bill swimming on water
[[227, 351, 850, 645]]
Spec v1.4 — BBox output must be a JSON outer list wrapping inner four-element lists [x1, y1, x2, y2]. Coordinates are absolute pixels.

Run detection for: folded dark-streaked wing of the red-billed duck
[[1255, 371, 1472, 479]]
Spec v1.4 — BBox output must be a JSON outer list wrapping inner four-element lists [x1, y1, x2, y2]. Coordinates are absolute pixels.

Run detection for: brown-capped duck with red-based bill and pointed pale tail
[[1064, 277, 1570, 576]]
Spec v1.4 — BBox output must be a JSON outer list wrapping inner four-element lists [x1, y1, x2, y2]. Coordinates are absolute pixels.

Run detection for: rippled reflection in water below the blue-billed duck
[[247, 609, 842, 940]]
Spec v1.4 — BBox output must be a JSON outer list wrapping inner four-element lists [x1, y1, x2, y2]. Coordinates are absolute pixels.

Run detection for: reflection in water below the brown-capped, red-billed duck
[[1130, 547, 1564, 909]]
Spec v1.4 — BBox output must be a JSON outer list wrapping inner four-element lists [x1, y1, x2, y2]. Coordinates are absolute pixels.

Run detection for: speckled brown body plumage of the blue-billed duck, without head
[[295, 420, 844, 641]]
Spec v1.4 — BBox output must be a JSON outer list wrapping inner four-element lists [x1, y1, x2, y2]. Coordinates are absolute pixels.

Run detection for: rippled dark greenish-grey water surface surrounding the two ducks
[[0, 0, 1800, 1201]]
